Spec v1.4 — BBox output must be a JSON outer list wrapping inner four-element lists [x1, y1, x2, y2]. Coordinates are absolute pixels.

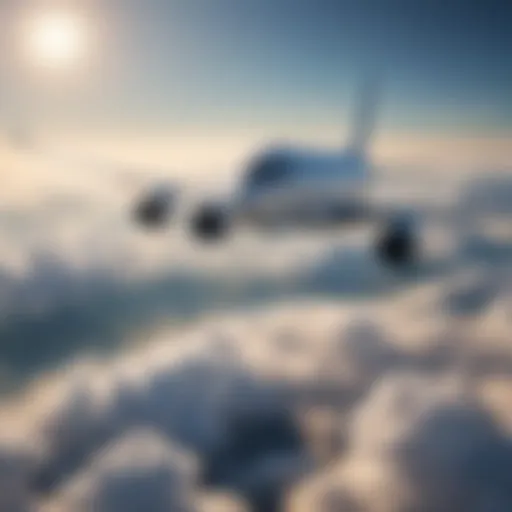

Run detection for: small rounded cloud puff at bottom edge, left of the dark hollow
[[50, 430, 197, 512]]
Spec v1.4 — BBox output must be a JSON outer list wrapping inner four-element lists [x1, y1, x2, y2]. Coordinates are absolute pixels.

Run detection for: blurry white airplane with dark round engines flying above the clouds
[[190, 82, 418, 266]]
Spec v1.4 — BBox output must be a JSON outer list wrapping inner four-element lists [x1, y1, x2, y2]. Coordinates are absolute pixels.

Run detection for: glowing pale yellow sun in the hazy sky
[[25, 12, 87, 69]]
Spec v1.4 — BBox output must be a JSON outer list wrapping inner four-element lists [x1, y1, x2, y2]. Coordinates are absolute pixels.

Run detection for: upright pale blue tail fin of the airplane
[[349, 78, 380, 154]]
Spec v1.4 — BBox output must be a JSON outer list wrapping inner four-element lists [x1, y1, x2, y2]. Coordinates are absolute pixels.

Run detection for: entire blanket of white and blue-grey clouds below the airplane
[[0, 142, 512, 512]]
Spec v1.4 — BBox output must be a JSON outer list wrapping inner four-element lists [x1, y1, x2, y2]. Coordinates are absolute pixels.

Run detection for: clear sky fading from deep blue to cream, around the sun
[[0, 0, 512, 140]]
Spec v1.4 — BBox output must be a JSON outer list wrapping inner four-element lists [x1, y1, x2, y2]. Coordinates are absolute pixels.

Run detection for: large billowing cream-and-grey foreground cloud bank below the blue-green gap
[[0, 284, 512, 512]]
